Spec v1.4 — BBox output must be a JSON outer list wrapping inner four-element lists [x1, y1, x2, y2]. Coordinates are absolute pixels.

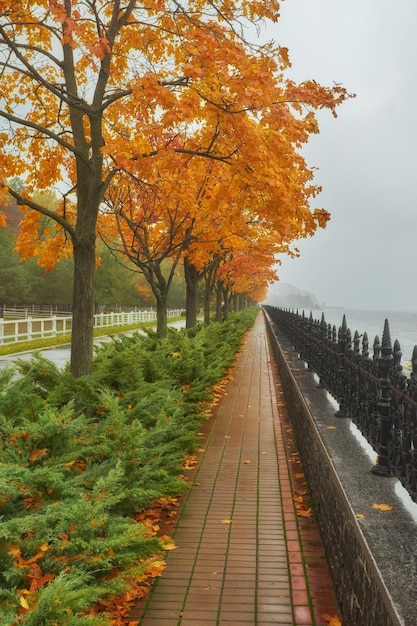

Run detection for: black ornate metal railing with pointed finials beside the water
[[265, 306, 417, 502]]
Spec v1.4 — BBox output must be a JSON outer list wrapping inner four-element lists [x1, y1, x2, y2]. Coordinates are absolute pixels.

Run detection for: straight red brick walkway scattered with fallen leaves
[[131, 313, 338, 626]]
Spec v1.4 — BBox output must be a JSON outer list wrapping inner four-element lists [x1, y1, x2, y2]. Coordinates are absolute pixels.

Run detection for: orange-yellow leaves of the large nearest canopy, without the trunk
[[0, 0, 347, 293]]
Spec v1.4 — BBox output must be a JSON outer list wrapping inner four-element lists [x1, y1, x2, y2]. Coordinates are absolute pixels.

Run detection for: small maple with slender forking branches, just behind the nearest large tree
[[100, 159, 193, 337]]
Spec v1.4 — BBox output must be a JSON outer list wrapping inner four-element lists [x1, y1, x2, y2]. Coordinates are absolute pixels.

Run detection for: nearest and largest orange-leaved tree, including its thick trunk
[[0, 0, 348, 377]]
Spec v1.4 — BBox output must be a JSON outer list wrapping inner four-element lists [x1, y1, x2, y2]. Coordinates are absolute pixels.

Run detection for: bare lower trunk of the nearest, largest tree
[[71, 237, 96, 378]]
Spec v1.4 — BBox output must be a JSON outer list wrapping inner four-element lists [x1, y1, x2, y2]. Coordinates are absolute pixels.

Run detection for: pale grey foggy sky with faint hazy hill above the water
[[264, 0, 417, 311]]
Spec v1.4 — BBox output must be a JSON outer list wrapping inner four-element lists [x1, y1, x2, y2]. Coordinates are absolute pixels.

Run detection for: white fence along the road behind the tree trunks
[[0, 309, 182, 345]]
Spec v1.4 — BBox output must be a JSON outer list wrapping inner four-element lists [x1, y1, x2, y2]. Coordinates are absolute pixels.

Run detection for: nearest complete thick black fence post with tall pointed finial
[[371, 320, 393, 476]]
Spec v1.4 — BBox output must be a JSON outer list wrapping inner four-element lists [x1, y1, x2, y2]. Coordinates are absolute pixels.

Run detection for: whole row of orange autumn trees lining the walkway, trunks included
[[0, 0, 349, 377]]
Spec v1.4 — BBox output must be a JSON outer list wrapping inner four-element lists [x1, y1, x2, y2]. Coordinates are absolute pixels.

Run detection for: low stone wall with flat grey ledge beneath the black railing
[[265, 314, 417, 626]]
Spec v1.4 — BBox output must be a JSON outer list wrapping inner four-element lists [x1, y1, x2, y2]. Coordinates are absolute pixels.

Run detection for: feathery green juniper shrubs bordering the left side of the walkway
[[0, 308, 257, 626]]
